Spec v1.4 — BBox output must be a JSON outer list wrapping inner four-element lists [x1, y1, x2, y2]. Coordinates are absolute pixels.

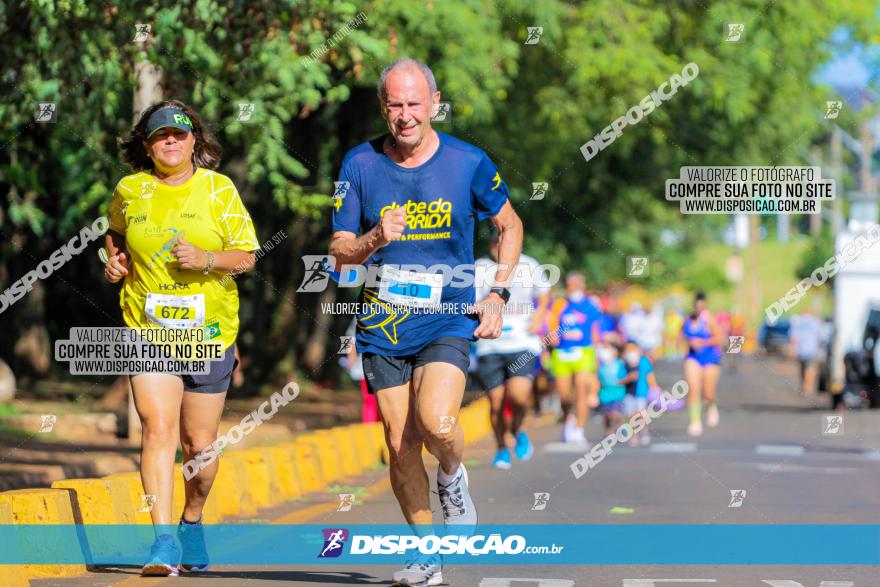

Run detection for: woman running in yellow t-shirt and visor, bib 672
[[104, 100, 259, 576]]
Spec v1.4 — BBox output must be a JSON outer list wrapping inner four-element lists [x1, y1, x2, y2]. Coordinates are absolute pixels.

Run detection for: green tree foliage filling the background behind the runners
[[0, 0, 877, 388]]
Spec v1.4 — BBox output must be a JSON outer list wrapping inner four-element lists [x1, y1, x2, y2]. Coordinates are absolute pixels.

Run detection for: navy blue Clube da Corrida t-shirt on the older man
[[333, 132, 509, 356]]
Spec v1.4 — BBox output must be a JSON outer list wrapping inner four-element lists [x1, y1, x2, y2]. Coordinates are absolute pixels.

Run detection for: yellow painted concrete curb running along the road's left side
[[0, 397, 491, 587]]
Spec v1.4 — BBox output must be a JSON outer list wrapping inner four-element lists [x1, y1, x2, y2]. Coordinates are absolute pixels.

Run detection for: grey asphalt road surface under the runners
[[32, 357, 880, 587]]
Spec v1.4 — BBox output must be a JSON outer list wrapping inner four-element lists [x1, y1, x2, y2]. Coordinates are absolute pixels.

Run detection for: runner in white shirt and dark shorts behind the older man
[[476, 233, 550, 469]]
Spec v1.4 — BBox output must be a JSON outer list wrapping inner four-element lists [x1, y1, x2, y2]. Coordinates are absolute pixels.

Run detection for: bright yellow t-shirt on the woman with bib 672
[[110, 168, 260, 348]]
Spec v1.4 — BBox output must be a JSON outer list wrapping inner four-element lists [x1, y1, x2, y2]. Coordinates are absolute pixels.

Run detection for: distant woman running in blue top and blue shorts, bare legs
[[681, 292, 722, 436]]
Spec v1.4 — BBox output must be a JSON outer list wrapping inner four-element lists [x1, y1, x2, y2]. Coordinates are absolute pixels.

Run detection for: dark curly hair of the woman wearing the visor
[[117, 100, 223, 171]]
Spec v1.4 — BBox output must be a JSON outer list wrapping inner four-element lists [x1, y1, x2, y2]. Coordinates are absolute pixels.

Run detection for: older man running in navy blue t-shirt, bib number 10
[[330, 59, 523, 585]]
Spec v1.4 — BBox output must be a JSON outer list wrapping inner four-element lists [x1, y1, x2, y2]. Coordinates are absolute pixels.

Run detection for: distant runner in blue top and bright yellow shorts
[[550, 271, 602, 444]]
